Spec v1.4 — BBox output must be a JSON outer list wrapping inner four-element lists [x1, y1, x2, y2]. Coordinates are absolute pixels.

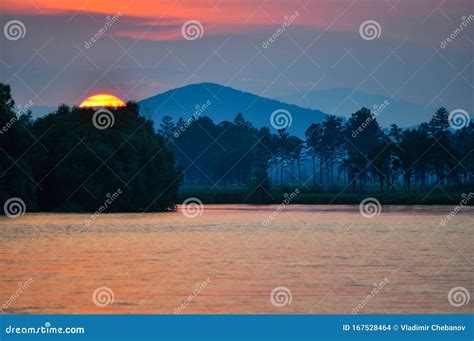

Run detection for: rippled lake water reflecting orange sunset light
[[0, 205, 474, 314]]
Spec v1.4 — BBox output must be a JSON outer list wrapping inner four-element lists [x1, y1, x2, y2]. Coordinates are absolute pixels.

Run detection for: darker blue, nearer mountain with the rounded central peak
[[138, 83, 326, 137]]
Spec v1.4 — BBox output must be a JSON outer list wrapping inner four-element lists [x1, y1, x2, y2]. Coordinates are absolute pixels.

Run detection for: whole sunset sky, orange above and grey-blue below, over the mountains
[[0, 0, 474, 112]]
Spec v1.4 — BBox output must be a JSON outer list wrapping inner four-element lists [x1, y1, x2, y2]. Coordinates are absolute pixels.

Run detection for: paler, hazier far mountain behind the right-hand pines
[[278, 88, 436, 127]]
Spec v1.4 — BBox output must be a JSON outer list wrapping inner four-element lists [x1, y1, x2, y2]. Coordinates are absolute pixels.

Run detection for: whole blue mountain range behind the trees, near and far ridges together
[[27, 82, 435, 137]]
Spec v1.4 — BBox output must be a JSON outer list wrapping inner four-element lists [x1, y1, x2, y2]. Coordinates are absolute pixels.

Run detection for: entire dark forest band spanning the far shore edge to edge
[[0, 84, 474, 212]]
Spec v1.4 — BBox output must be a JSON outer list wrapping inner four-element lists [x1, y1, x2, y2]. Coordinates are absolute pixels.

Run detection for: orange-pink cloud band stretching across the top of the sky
[[2, 0, 470, 41]]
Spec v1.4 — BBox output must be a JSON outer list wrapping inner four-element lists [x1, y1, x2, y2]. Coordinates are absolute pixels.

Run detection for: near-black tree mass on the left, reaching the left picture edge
[[0, 84, 181, 213]]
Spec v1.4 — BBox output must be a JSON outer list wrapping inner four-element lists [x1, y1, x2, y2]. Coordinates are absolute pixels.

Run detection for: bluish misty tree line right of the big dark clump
[[158, 108, 474, 192]]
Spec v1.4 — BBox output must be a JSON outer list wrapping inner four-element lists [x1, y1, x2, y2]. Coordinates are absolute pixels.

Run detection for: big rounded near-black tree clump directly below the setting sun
[[28, 102, 180, 211]]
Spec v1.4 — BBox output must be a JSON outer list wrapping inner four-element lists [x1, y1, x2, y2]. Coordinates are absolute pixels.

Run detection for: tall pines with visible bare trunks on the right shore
[[306, 107, 474, 192]]
